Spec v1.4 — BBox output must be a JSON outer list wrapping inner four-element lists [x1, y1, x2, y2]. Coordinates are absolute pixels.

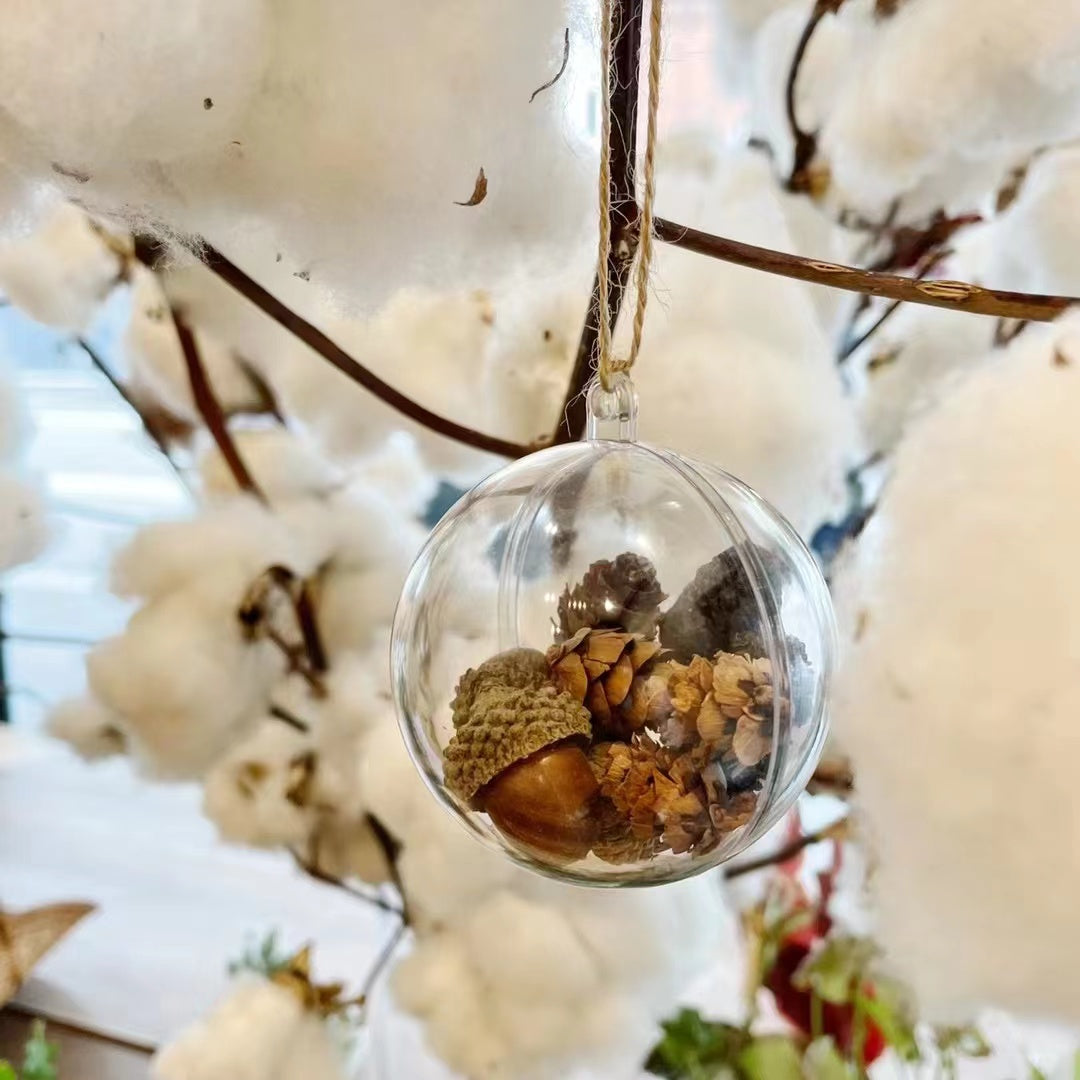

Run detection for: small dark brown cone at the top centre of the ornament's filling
[[558, 552, 666, 639]]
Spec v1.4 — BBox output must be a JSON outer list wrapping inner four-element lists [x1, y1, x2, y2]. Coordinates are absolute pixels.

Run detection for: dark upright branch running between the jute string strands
[[551, 0, 644, 443]]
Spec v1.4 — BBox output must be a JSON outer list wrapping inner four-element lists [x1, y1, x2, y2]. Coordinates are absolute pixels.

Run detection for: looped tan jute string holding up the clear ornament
[[597, 0, 663, 390]]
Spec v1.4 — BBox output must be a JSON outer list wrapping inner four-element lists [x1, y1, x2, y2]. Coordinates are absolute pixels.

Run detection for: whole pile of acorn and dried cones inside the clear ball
[[444, 549, 799, 864]]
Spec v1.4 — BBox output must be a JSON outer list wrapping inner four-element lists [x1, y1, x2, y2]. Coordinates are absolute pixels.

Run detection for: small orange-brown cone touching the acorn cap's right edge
[[548, 626, 660, 731]]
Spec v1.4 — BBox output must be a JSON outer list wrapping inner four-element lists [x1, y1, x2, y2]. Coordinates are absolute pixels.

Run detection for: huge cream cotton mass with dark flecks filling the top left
[[0, 0, 594, 310]]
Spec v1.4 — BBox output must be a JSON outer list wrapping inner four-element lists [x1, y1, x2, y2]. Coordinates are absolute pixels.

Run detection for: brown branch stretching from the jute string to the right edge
[[656, 218, 1080, 323]]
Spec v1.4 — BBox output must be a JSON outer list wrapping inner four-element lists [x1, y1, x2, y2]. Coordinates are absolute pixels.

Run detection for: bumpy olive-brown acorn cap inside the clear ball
[[443, 649, 591, 802]]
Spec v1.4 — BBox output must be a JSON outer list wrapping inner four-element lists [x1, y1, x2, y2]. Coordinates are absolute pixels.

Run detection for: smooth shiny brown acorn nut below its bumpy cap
[[475, 742, 599, 862]]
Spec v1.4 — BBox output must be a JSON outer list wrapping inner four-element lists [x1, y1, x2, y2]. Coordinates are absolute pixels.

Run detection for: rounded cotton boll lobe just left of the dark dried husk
[[86, 578, 284, 778]]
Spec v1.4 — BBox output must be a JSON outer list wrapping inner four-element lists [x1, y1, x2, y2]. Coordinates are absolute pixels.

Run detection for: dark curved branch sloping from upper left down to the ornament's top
[[135, 236, 539, 458]]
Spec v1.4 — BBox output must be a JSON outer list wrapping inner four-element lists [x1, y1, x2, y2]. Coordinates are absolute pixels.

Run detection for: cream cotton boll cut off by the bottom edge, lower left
[[151, 980, 346, 1080]]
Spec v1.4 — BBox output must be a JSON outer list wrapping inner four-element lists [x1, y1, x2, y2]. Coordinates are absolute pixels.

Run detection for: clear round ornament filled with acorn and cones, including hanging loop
[[391, 375, 836, 886]]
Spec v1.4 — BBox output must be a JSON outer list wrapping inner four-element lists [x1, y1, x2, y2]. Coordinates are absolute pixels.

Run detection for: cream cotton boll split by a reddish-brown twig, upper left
[[123, 267, 267, 420]]
